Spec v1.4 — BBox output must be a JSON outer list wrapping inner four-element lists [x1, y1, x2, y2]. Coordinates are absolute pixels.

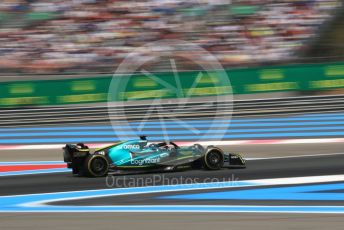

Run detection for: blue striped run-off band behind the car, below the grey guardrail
[[0, 113, 344, 144]]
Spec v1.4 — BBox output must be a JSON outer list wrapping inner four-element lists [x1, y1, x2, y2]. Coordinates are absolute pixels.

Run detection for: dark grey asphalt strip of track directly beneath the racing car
[[0, 147, 344, 195]]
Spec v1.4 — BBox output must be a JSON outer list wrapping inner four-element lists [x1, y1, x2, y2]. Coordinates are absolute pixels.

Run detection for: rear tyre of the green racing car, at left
[[84, 155, 109, 177]]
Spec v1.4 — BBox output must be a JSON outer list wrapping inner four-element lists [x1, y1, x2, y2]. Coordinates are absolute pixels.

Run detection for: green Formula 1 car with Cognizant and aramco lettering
[[63, 136, 245, 177]]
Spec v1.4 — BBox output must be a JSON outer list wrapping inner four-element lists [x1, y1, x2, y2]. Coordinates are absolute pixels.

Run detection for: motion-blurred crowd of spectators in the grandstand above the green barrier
[[0, 0, 341, 73]]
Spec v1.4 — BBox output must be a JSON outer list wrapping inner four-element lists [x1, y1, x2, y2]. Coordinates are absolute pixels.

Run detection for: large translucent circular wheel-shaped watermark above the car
[[107, 39, 233, 143]]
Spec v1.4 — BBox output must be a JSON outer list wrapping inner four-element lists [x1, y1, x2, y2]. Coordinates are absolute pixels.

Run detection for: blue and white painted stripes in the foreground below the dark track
[[0, 181, 344, 214]]
